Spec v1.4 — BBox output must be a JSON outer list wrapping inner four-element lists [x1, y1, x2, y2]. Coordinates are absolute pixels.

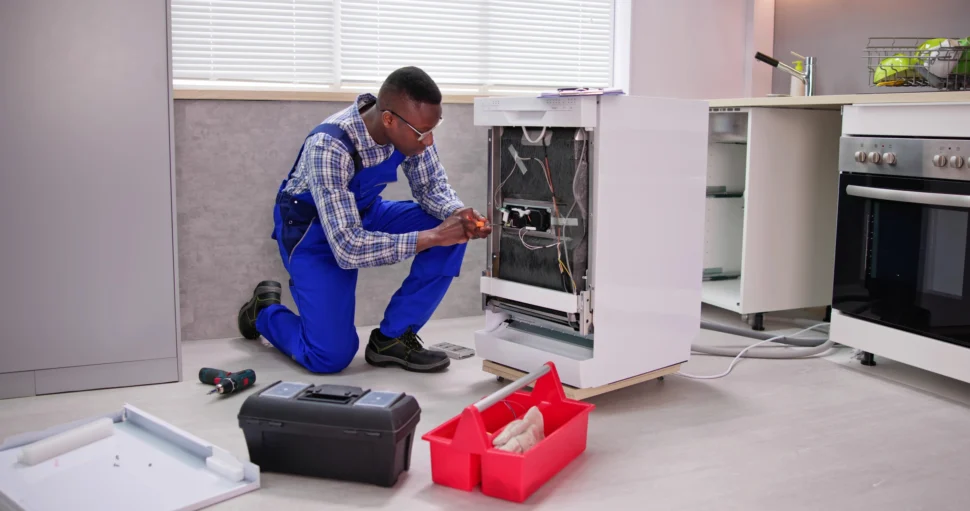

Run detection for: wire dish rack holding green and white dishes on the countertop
[[863, 37, 970, 91]]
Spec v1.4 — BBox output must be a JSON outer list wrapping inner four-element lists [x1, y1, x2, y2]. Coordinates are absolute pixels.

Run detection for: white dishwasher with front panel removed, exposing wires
[[475, 95, 708, 388]]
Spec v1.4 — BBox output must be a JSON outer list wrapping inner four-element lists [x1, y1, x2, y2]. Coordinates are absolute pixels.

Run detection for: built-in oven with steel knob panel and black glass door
[[832, 136, 970, 347]]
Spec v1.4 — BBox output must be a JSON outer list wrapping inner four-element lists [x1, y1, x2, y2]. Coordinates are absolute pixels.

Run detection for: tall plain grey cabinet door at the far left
[[0, 0, 177, 373]]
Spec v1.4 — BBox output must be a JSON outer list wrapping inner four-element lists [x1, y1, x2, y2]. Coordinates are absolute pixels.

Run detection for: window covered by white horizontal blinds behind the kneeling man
[[172, 0, 614, 94]]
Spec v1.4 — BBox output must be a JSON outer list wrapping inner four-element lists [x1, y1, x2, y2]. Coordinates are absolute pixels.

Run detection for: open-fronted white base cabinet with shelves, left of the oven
[[702, 108, 841, 324]]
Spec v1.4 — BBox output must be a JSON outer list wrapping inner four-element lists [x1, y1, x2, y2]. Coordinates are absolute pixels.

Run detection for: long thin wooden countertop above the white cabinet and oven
[[708, 91, 970, 110]]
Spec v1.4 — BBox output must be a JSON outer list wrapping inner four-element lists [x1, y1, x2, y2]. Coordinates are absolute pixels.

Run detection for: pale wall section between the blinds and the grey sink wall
[[629, 0, 776, 99]]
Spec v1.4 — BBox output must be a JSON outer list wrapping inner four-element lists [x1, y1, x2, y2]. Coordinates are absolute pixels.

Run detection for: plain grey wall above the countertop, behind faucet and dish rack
[[772, 0, 970, 94]]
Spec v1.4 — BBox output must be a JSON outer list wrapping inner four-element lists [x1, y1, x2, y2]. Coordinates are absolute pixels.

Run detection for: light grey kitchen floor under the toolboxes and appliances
[[0, 310, 970, 511]]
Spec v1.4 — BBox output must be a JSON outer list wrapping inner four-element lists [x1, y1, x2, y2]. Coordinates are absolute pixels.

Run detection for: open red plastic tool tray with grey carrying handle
[[422, 362, 595, 502]]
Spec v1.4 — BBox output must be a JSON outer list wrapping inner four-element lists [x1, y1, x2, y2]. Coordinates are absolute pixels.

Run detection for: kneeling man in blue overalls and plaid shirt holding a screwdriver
[[238, 67, 491, 373]]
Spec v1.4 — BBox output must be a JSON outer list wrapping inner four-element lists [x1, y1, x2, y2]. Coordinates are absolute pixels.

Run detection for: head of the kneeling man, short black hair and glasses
[[377, 67, 441, 156]]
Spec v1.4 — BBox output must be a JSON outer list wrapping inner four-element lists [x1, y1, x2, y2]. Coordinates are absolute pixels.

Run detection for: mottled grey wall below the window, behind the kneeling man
[[175, 100, 487, 340]]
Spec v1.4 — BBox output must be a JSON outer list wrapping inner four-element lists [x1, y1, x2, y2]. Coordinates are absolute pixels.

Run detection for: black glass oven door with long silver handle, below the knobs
[[832, 173, 970, 347]]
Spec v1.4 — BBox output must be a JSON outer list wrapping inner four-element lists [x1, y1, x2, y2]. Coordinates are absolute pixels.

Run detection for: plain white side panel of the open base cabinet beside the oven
[[741, 108, 841, 314]]
